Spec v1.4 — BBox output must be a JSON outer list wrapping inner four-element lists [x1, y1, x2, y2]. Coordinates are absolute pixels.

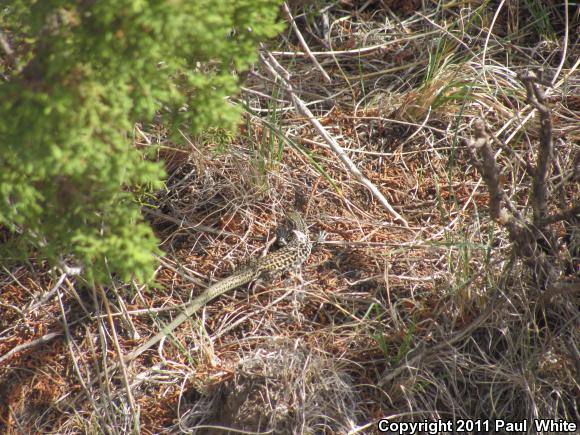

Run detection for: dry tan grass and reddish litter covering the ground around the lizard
[[0, 0, 580, 434]]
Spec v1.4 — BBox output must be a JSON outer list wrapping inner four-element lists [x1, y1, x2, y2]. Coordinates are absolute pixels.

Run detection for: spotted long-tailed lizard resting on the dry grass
[[123, 211, 312, 363]]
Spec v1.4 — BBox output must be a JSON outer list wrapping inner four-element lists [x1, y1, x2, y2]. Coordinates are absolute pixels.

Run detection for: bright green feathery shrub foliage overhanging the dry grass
[[0, 0, 281, 281]]
